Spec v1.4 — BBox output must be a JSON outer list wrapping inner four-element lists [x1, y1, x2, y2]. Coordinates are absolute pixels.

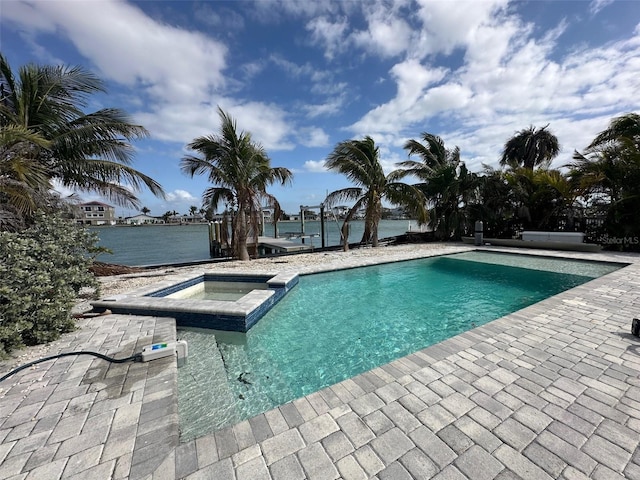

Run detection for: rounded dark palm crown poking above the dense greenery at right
[[500, 125, 560, 170]]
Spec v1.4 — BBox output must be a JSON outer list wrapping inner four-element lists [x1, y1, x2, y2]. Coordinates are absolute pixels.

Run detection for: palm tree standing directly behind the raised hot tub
[[181, 107, 293, 260]]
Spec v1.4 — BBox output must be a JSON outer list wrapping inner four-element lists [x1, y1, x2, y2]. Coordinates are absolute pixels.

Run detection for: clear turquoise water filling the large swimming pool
[[178, 252, 620, 441]]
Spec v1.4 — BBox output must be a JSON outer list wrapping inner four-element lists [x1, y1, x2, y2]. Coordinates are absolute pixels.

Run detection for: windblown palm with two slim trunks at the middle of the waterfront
[[325, 136, 427, 250]]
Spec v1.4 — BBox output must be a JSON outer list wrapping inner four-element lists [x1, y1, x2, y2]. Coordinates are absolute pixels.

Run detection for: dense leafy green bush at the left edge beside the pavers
[[0, 214, 99, 355]]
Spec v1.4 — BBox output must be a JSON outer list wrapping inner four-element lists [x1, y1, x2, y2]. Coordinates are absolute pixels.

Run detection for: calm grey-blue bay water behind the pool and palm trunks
[[91, 220, 419, 266]]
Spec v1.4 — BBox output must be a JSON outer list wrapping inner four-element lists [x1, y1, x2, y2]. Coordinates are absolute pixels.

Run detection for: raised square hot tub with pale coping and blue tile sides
[[91, 273, 299, 332]]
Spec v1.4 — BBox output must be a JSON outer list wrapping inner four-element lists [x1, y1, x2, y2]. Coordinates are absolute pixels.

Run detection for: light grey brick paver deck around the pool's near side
[[0, 246, 640, 480]]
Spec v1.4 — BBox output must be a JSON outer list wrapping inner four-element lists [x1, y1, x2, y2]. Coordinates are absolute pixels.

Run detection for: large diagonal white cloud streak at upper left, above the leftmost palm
[[11, 0, 227, 99]]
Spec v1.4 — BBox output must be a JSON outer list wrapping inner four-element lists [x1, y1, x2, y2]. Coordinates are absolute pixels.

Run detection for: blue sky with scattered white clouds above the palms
[[0, 0, 640, 215]]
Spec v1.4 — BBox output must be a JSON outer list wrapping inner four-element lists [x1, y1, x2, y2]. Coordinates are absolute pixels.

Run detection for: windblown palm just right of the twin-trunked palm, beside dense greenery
[[398, 132, 478, 240]]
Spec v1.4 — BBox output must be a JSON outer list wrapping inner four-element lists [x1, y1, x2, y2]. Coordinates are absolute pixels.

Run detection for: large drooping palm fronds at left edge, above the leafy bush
[[0, 54, 164, 229]]
